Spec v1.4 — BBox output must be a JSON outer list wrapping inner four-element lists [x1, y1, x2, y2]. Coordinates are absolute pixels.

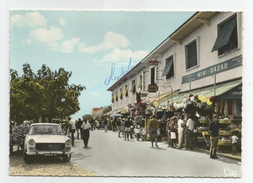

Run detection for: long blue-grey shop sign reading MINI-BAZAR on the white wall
[[182, 55, 242, 83]]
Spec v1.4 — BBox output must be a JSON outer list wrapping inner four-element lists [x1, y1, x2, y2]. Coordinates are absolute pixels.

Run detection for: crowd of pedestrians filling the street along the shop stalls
[[64, 114, 238, 159]]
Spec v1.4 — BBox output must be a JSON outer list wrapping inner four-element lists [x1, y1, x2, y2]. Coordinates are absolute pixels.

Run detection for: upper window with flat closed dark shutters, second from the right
[[186, 40, 198, 69]]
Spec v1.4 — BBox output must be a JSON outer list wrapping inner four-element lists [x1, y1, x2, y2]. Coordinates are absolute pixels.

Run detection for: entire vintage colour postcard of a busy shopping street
[[9, 10, 244, 178]]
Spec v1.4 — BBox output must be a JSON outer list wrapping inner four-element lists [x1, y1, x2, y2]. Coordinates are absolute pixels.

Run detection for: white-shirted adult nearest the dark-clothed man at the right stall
[[184, 114, 194, 150]]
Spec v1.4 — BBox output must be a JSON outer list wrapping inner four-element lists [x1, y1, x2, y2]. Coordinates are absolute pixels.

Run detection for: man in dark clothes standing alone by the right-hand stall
[[208, 114, 219, 159]]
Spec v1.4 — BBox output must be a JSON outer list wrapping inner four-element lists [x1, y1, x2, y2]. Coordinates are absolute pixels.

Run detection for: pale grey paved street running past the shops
[[71, 130, 241, 177]]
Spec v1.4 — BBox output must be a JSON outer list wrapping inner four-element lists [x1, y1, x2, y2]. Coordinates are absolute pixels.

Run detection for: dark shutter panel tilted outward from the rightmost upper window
[[212, 16, 236, 52]]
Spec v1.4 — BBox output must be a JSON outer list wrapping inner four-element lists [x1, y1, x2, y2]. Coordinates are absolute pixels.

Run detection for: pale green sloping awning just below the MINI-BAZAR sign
[[168, 79, 242, 103]]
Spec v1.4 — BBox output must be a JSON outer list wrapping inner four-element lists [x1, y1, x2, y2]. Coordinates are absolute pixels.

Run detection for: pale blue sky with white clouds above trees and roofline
[[10, 10, 195, 119]]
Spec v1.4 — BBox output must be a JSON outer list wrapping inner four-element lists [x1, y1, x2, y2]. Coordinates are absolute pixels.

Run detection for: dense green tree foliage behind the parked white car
[[10, 64, 86, 123]]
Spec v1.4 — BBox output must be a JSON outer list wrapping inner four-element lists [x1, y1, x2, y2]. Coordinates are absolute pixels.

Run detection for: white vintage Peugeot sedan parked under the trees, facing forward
[[23, 123, 72, 163]]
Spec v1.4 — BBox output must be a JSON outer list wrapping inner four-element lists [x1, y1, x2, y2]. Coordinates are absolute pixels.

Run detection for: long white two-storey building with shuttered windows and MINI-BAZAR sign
[[108, 12, 242, 115]]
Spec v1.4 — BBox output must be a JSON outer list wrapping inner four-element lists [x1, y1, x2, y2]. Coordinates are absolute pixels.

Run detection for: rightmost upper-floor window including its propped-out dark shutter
[[212, 15, 238, 55]]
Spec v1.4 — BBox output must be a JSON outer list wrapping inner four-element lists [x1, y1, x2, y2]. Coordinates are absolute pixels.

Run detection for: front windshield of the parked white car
[[29, 125, 64, 135]]
